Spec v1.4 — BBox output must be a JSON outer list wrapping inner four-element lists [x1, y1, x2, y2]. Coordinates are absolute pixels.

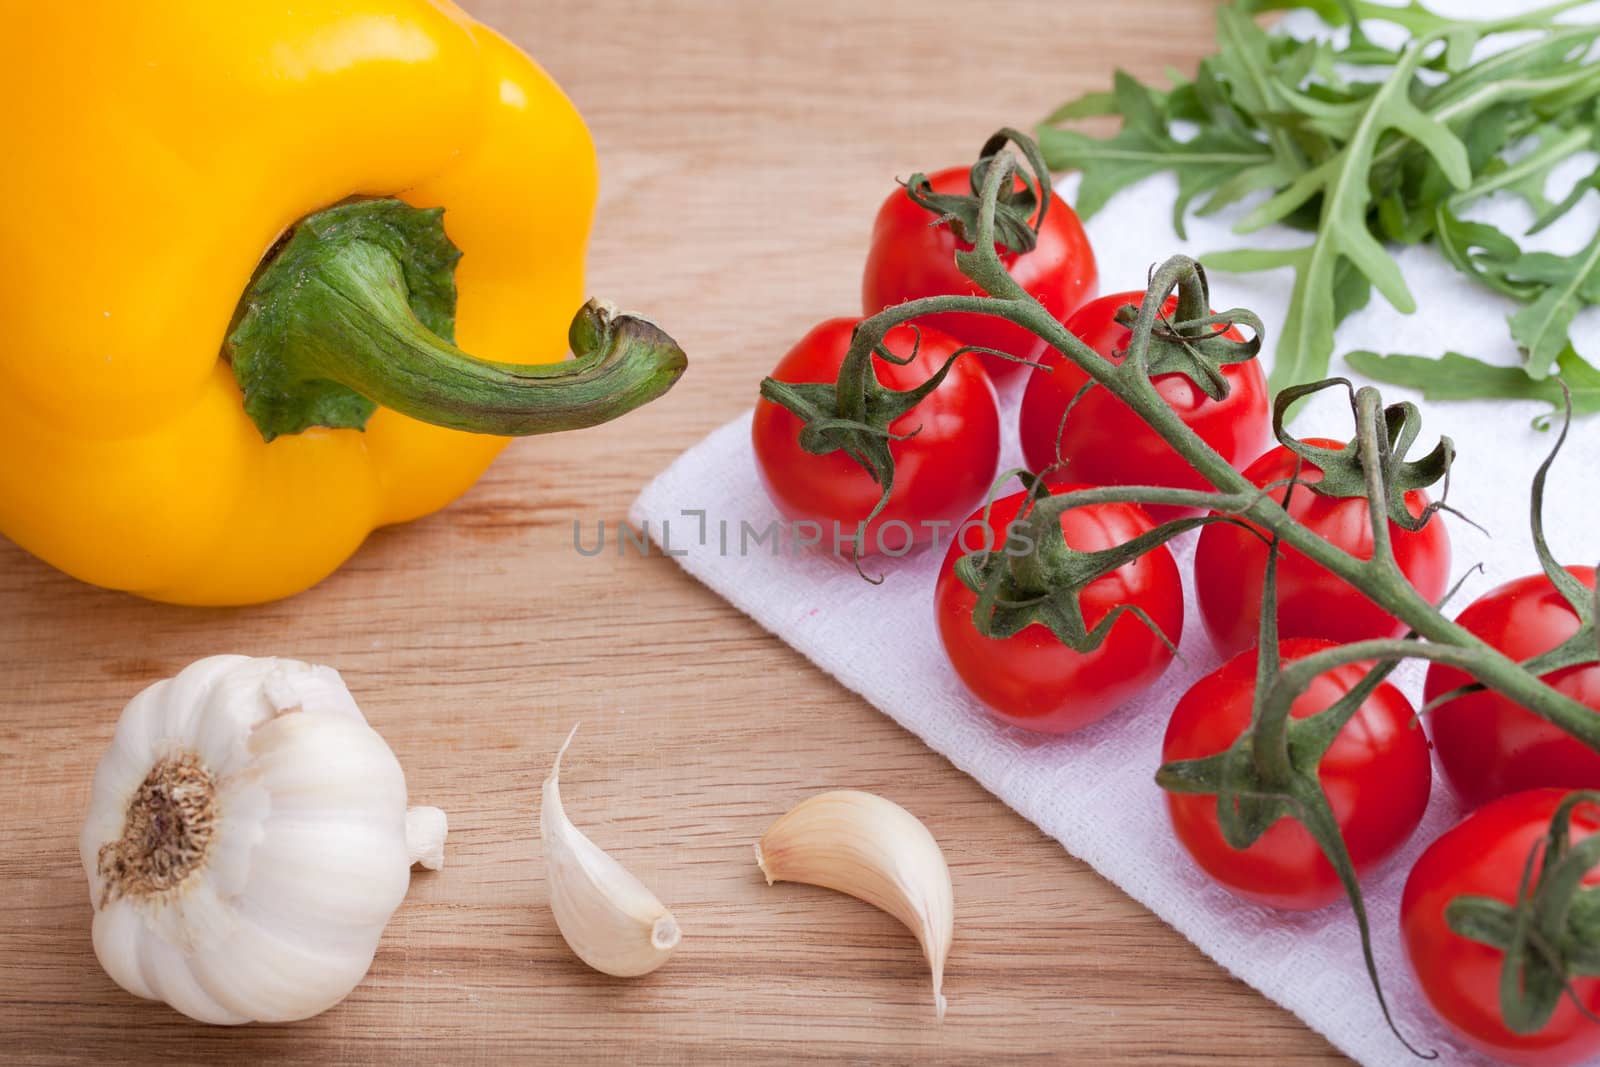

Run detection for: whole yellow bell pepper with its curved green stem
[[0, 0, 683, 605]]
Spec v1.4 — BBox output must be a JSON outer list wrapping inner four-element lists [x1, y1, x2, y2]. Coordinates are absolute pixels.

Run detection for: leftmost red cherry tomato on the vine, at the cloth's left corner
[[750, 318, 1000, 555]]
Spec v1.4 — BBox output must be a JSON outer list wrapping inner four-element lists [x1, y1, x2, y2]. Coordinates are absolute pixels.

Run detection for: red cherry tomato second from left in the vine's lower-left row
[[934, 485, 1184, 734]]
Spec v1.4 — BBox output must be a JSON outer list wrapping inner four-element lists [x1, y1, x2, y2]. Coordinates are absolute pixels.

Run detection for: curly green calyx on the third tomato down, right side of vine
[[1272, 378, 1475, 533]]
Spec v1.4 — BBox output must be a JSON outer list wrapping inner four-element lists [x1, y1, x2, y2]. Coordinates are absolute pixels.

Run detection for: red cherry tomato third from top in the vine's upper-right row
[[1195, 438, 1450, 656]]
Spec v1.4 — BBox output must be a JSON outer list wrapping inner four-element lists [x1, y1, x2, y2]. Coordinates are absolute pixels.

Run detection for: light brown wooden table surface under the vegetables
[[0, 0, 1334, 1064]]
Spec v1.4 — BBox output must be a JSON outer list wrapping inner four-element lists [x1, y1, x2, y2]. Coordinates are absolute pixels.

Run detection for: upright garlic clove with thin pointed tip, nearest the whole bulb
[[539, 726, 680, 977]]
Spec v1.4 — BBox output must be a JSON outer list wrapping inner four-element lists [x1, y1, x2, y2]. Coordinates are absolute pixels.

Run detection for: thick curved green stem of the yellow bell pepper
[[229, 200, 686, 440]]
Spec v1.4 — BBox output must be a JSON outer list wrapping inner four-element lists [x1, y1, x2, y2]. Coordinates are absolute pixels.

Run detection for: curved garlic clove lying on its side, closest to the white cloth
[[755, 789, 955, 1019]]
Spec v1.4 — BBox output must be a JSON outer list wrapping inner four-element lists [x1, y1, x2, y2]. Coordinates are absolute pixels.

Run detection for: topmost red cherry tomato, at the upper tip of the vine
[[861, 166, 1098, 381]]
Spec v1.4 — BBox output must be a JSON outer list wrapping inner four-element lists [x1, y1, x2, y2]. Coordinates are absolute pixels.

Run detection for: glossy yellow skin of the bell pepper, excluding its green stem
[[0, 0, 597, 605]]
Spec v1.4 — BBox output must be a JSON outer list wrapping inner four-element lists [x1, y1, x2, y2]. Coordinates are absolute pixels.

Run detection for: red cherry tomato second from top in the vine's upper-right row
[[1021, 293, 1272, 520]]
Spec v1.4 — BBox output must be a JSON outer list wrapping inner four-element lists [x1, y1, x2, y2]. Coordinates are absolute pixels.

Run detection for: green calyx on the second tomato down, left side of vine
[[955, 470, 1230, 654]]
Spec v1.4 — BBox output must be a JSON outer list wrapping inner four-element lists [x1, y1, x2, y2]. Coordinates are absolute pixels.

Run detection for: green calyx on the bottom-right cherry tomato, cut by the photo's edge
[[1445, 790, 1600, 1033]]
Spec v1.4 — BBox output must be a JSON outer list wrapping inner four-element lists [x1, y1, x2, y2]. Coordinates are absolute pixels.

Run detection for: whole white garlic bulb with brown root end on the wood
[[80, 656, 445, 1024]]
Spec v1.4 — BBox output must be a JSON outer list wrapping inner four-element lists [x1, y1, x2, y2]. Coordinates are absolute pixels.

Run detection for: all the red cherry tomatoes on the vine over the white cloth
[[754, 154, 1600, 1064]]
